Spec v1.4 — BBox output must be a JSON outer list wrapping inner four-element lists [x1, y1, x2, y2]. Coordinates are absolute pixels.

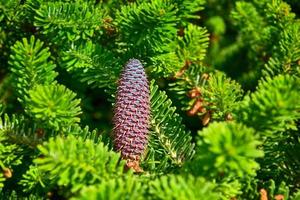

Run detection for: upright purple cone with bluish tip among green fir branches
[[113, 59, 150, 162]]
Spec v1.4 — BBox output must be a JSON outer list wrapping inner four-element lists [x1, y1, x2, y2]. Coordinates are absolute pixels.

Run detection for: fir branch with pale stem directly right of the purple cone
[[144, 81, 194, 171]]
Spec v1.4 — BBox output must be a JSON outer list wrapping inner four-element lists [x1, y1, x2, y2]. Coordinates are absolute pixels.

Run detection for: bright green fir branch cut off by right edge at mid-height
[[236, 75, 300, 136]]
